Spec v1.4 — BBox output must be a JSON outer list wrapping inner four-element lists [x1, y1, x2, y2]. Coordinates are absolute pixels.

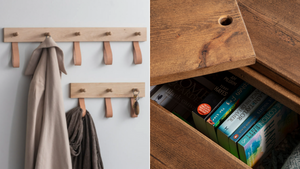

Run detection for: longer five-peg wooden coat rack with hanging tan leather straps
[[4, 28, 147, 67]]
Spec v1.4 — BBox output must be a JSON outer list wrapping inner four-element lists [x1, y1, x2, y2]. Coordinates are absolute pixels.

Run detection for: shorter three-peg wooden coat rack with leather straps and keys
[[70, 82, 145, 118]]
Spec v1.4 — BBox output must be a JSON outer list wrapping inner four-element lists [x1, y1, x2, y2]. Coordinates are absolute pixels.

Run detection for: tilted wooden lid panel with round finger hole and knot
[[151, 0, 255, 83]]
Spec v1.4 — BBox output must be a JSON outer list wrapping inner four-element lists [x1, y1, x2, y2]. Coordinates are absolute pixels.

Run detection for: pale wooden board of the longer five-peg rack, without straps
[[4, 27, 147, 42]]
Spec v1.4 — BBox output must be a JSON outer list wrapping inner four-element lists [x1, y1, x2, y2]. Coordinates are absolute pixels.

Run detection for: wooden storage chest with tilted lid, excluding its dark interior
[[151, 0, 300, 169]]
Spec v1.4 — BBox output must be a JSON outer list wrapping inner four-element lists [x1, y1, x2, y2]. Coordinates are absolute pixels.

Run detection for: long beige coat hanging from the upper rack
[[25, 37, 72, 169]]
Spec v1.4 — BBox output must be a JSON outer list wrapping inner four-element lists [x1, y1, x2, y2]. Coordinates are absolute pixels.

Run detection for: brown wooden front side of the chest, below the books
[[150, 100, 250, 169]]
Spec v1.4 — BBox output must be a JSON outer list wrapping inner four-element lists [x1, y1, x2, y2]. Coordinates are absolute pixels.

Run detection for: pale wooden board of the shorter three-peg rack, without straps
[[70, 82, 145, 98]]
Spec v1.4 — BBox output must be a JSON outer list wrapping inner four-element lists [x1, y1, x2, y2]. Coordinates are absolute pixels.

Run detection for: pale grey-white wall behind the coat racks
[[0, 0, 150, 169]]
